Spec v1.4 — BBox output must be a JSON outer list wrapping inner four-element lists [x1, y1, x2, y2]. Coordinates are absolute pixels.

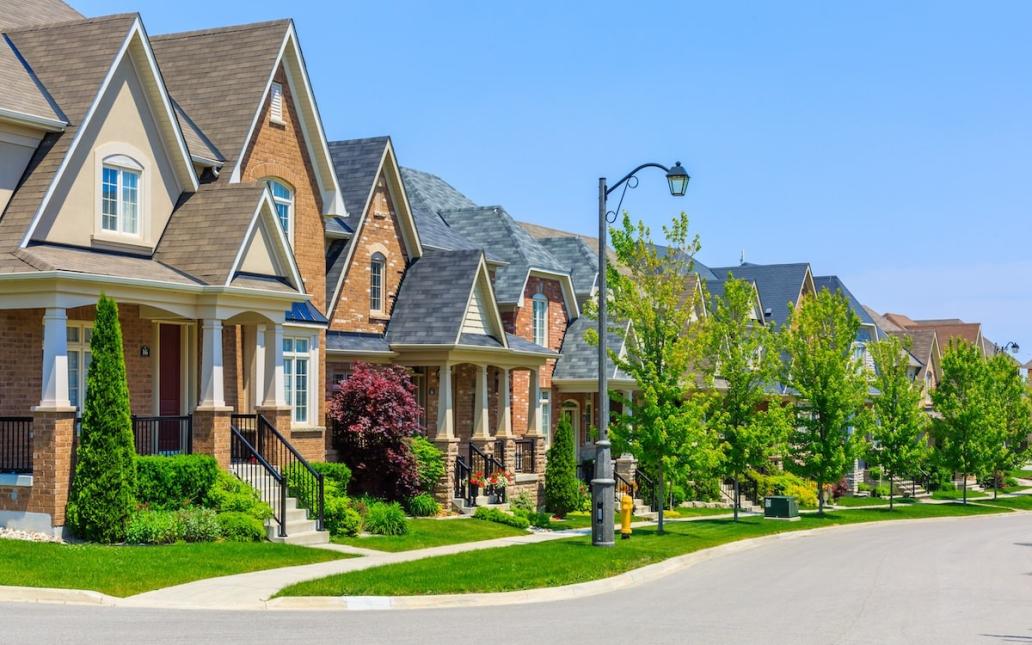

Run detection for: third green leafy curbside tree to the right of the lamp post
[[784, 289, 869, 513]]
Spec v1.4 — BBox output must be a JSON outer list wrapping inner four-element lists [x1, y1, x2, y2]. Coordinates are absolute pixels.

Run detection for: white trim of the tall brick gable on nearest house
[[229, 21, 348, 217]]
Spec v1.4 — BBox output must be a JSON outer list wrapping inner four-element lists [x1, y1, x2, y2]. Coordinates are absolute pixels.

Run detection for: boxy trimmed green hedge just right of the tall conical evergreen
[[136, 455, 219, 511]]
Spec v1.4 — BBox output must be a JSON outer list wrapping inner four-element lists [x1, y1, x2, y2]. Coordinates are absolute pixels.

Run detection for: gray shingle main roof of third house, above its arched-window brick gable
[[441, 206, 569, 304]]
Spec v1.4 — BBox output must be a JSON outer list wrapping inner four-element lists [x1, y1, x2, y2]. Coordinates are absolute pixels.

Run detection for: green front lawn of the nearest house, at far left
[[0, 540, 346, 598]]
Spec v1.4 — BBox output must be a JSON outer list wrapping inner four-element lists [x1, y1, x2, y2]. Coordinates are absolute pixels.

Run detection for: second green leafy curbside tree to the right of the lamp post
[[701, 277, 792, 521]]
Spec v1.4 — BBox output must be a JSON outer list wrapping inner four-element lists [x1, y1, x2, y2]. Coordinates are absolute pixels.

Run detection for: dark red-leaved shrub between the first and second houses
[[328, 363, 422, 501]]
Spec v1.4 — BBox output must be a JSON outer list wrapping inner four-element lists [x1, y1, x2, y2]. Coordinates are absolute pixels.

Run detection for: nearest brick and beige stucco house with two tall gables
[[0, 0, 347, 527]]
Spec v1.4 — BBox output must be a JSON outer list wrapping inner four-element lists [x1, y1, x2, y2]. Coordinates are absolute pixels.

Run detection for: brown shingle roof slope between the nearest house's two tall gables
[[149, 20, 290, 177]]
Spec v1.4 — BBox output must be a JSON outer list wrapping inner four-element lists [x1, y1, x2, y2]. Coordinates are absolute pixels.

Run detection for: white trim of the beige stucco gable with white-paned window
[[21, 18, 198, 249]]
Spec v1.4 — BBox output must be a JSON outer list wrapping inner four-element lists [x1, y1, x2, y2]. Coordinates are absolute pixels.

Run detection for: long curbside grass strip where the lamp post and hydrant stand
[[277, 504, 1009, 595]]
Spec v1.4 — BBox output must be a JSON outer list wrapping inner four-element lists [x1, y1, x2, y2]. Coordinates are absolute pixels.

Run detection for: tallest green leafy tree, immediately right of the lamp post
[[589, 213, 717, 533]]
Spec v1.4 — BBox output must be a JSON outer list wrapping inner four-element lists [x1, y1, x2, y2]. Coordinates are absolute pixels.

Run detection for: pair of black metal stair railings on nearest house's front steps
[[230, 415, 326, 535]]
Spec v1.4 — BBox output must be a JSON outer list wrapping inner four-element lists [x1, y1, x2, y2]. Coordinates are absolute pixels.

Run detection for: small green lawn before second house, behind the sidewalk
[[333, 518, 526, 552]]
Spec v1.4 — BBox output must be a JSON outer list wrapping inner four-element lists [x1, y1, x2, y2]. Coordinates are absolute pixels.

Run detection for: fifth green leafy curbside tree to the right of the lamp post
[[932, 340, 1002, 504]]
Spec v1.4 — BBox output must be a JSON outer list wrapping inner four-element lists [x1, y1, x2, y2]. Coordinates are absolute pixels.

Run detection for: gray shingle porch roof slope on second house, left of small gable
[[387, 250, 481, 345]]
